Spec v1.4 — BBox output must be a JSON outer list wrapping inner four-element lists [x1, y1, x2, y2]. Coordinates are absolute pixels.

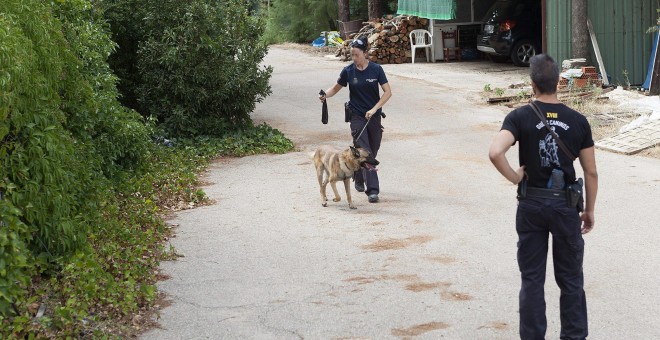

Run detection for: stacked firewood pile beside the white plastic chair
[[337, 16, 429, 64]]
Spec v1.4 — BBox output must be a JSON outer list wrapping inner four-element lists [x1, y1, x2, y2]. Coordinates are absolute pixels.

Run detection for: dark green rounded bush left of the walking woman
[[103, 0, 272, 136]]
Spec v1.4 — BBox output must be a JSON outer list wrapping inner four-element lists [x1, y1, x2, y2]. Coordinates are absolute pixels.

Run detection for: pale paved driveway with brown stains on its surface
[[144, 48, 660, 339]]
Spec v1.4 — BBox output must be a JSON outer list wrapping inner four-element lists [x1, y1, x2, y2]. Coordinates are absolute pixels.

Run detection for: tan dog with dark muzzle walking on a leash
[[314, 145, 378, 209]]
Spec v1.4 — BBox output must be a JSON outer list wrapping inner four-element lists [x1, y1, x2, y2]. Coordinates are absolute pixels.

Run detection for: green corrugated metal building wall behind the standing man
[[546, 0, 657, 85]]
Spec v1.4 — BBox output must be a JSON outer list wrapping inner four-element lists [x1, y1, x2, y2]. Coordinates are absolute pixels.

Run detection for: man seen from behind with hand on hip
[[489, 54, 598, 339]]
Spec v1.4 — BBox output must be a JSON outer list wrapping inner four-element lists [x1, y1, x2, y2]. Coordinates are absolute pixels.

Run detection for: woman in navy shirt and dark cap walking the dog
[[319, 38, 392, 203]]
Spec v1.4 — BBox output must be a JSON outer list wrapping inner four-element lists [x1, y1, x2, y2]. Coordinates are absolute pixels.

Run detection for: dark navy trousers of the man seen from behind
[[516, 197, 588, 340]]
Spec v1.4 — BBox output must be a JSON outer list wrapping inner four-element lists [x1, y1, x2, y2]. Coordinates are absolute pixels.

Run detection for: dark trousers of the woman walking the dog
[[351, 114, 383, 195]]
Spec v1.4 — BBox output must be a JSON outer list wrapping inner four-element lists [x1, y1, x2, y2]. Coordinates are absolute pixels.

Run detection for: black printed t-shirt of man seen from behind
[[502, 101, 594, 188]]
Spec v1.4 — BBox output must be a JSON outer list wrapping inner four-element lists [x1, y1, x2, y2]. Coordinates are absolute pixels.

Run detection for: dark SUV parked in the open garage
[[477, 0, 542, 66]]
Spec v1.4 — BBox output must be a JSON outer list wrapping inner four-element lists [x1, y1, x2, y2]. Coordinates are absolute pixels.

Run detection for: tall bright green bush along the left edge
[[0, 0, 150, 317]]
